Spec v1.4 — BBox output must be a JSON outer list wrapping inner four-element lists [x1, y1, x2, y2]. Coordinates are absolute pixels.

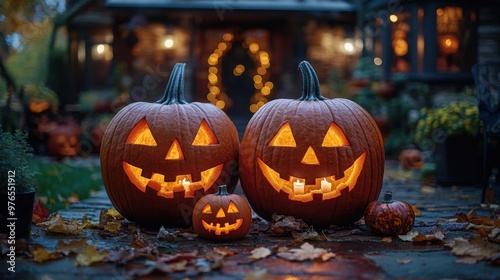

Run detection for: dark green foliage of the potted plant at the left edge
[[0, 127, 36, 193]]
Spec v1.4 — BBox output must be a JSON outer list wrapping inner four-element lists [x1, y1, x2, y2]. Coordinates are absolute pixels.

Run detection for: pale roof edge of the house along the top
[[104, 0, 355, 12]]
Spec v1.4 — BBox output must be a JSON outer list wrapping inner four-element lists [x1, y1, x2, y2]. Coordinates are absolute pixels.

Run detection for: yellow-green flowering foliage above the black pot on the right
[[416, 94, 481, 142]]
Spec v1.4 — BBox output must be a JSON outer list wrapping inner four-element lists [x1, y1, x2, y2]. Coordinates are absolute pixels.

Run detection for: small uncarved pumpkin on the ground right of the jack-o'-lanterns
[[365, 191, 415, 236]]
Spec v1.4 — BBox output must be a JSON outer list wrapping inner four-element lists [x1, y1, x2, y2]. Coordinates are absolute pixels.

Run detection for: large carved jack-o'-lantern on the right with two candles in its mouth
[[239, 61, 384, 227]]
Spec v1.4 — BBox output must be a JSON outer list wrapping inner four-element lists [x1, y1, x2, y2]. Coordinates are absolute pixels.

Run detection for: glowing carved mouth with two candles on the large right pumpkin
[[257, 152, 366, 202]]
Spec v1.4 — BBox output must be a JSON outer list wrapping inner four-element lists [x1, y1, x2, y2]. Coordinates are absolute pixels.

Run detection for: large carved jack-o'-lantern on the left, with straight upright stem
[[100, 64, 239, 228]]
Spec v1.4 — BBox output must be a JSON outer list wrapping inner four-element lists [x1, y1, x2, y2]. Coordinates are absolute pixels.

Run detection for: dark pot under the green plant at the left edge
[[0, 191, 35, 239]]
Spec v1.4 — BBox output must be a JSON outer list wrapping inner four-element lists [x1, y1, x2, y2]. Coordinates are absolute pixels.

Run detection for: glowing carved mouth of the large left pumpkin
[[123, 161, 224, 198]]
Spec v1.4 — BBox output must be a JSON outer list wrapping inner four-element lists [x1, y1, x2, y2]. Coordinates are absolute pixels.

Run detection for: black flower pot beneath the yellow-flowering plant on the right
[[434, 135, 482, 186]]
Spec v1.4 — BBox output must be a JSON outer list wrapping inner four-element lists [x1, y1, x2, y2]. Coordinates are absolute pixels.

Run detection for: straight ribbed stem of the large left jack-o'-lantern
[[156, 63, 188, 105]]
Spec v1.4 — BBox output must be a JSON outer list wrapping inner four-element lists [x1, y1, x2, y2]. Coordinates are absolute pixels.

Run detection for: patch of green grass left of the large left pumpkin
[[29, 157, 103, 212]]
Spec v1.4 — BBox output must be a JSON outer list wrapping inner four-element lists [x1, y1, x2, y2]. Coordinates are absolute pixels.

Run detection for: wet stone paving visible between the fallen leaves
[[0, 162, 500, 279]]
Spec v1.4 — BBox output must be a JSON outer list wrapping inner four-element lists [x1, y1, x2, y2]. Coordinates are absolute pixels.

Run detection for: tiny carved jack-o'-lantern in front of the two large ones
[[193, 185, 252, 241]]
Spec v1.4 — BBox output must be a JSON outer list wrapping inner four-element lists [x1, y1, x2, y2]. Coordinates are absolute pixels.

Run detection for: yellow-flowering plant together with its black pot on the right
[[415, 96, 481, 185]]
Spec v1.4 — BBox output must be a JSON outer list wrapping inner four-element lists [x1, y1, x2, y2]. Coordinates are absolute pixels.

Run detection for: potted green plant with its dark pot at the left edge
[[0, 126, 36, 237]]
